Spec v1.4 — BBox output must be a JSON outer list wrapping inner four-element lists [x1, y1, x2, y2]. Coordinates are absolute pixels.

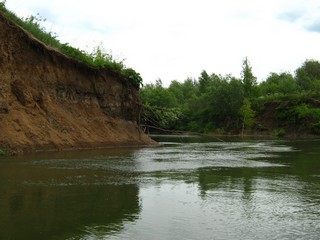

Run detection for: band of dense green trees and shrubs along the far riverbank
[[140, 58, 320, 136]]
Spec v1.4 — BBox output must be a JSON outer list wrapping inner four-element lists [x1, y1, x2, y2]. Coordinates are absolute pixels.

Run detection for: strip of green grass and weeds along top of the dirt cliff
[[0, 1, 142, 89]]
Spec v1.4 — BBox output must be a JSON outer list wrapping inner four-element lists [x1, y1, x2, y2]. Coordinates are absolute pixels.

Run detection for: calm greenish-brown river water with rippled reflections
[[0, 136, 320, 240]]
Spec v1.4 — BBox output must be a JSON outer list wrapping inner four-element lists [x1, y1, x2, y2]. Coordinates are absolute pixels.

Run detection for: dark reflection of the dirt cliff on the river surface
[[0, 151, 141, 240]]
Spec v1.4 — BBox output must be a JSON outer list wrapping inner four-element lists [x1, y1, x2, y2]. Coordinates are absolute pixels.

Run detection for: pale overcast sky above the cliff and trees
[[6, 0, 320, 86]]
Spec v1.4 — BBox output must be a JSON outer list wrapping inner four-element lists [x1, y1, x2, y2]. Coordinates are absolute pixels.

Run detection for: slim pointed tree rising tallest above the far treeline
[[241, 57, 257, 99]]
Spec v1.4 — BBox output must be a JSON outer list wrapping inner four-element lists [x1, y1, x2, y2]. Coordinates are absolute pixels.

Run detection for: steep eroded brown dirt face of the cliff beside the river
[[0, 13, 154, 152]]
